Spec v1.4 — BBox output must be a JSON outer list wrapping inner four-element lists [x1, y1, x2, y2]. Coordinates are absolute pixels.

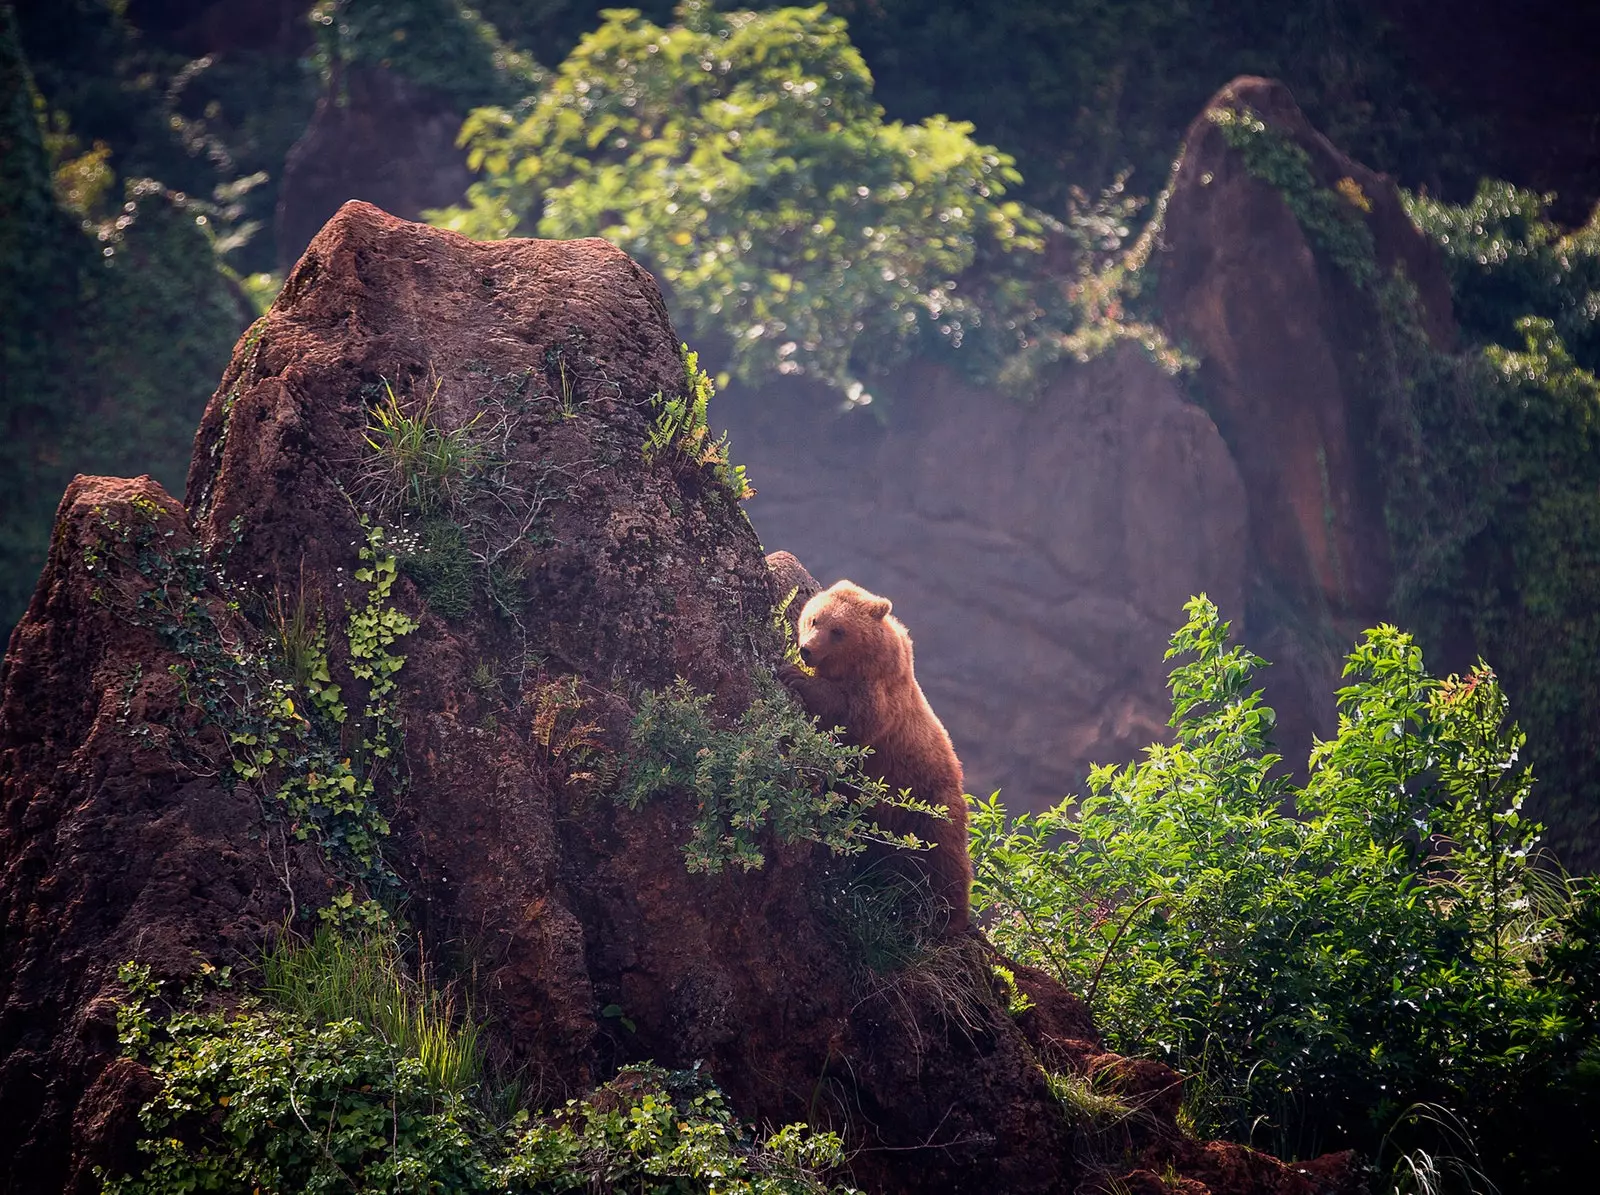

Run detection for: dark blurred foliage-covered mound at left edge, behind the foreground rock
[[0, 18, 243, 625]]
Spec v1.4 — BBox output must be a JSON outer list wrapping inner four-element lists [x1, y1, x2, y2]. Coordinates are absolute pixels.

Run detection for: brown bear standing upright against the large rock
[[779, 581, 973, 934]]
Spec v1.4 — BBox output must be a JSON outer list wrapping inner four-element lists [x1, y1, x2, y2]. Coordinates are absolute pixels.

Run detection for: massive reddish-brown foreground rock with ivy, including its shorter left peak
[[0, 203, 1357, 1195]]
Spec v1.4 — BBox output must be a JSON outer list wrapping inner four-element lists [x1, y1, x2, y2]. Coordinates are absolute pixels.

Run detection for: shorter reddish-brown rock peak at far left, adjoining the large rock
[[0, 477, 331, 1192]]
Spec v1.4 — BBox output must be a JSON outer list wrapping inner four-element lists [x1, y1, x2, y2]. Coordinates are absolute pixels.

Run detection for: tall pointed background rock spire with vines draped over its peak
[[1157, 77, 1454, 757]]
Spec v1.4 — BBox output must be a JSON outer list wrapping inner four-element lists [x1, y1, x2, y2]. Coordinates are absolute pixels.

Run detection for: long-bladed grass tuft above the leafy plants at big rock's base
[[261, 926, 483, 1093]]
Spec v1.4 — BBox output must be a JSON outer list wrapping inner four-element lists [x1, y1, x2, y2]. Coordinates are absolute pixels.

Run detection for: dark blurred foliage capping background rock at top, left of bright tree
[[310, 0, 544, 112]]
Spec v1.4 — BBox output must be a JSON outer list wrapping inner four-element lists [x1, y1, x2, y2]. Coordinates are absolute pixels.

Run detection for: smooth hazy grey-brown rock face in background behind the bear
[[715, 350, 1248, 808]]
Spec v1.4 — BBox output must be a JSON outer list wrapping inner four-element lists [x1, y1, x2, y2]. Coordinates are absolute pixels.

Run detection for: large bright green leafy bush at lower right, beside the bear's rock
[[973, 598, 1600, 1155]]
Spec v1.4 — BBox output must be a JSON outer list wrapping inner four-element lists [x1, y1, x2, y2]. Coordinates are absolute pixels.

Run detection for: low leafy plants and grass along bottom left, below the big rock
[[104, 959, 846, 1195]]
